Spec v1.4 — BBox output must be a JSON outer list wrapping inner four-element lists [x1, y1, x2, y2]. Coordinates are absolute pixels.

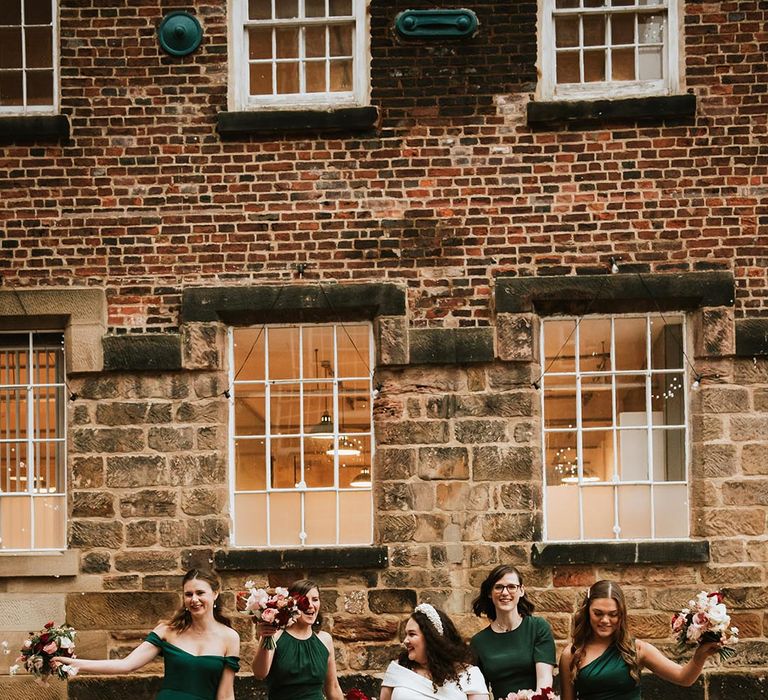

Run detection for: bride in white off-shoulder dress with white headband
[[379, 603, 488, 700]]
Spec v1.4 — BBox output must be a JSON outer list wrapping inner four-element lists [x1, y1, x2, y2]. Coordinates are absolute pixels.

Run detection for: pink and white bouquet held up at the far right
[[672, 591, 739, 661]]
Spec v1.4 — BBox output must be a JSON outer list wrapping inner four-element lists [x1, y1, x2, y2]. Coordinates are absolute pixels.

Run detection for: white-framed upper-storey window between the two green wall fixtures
[[232, 0, 368, 109]]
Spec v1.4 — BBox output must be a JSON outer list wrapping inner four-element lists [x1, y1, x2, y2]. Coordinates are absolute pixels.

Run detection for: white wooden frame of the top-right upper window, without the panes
[[537, 0, 682, 100]]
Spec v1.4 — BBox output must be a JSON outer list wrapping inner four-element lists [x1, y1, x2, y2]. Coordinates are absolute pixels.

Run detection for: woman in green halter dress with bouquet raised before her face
[[252, 579, 344, 700]]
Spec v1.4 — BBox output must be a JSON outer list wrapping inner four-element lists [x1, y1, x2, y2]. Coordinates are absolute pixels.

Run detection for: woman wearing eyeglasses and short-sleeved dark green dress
[[470, 564, 555, 698]]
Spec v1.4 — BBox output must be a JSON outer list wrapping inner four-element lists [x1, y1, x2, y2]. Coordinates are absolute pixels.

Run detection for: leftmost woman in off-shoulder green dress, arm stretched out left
[[57, 569, 240, 700]]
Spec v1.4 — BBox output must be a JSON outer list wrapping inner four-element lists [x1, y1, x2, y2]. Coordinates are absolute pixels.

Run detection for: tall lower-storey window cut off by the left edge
[[0, 332, 67, 552]]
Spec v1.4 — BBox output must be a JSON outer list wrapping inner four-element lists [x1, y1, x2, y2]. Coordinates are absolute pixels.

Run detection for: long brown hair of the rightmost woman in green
[[570, 580, 640, 683]]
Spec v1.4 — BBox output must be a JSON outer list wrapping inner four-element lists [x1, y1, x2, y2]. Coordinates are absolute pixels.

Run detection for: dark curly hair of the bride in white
[[397, 608, 473, 692]]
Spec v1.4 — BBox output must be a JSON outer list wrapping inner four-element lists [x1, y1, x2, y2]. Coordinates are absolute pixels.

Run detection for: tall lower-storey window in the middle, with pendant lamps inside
[[230, 322, 373, 547]]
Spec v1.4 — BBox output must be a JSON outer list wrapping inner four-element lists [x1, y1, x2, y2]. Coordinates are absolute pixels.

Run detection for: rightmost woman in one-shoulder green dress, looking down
[[560, 581, 720, 700]]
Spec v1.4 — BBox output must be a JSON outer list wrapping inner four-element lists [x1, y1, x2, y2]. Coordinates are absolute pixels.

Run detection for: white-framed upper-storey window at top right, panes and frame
[[539, 0, 679, 99]]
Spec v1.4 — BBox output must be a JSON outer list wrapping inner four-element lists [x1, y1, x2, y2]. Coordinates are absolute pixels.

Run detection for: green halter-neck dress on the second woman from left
[[266, 632, 329, 700]]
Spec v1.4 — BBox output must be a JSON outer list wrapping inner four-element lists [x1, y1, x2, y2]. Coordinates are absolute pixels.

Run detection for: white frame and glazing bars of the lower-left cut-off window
[[0, 330, 68, 556]]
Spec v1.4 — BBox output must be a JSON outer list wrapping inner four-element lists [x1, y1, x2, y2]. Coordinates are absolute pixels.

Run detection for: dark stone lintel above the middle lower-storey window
[[181, 283, 406, 325]]
